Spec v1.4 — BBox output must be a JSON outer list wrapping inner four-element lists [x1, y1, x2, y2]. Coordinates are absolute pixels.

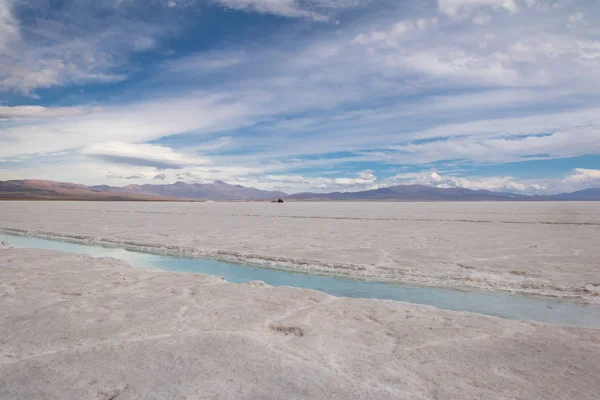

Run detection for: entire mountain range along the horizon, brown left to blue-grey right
[[0, 179, 600, 201]]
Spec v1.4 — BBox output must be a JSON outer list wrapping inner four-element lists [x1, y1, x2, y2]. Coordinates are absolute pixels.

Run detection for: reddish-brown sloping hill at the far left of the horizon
[[0, 179, 182, 201]]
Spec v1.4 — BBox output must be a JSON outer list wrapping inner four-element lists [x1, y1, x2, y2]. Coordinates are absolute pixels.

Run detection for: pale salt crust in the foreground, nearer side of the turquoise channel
[[0, 249, 600, 400]]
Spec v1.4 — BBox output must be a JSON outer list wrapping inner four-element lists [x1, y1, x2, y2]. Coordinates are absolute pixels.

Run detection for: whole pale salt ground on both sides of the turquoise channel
[[0, 202, 600, 399]]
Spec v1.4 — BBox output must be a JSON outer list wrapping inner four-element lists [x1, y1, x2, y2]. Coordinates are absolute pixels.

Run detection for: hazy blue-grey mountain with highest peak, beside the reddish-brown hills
[[91, 181, 287, 200]]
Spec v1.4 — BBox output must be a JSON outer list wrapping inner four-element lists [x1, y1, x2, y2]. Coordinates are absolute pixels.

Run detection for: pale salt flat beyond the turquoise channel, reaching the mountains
[[0, 202, 600, 302]]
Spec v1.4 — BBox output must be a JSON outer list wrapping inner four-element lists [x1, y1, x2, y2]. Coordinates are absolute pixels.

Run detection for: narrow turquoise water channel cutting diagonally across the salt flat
[[0, 234, 600, 328]]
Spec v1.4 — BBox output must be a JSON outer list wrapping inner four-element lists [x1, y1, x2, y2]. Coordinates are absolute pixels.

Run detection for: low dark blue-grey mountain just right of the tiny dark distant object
[[287, 185, 529, 201]]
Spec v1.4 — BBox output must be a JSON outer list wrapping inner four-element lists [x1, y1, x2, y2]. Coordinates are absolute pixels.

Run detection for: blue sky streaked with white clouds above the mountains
[[0, 0, 600, 194]]
